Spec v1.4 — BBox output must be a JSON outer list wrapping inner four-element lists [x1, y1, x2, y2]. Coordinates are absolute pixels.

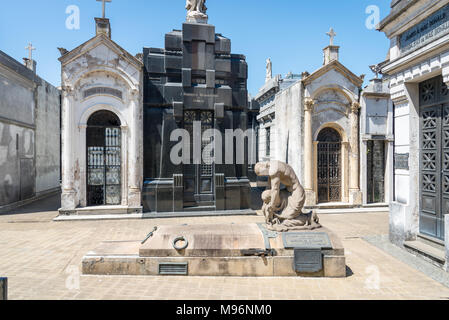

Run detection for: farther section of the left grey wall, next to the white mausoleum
[[36, 80, 61, 194]]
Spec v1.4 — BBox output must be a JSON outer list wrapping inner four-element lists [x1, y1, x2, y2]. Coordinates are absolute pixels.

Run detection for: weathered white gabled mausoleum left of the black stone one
[[60, 18, 143, 214]]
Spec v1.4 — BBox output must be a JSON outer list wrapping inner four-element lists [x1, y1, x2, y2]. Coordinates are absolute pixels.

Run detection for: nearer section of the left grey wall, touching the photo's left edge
[[0, 59, 35, 206]]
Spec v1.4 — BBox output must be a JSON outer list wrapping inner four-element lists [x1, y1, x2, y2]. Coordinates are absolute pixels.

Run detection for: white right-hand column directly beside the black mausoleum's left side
[[128, 90, 142, 208]]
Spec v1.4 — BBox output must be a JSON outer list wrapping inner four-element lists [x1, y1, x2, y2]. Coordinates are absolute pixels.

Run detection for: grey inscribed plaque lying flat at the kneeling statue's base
[[282, 232, 332, 250]]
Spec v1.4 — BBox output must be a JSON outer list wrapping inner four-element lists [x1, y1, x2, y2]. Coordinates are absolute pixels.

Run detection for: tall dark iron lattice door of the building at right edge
[[419, 77, 449, 239]]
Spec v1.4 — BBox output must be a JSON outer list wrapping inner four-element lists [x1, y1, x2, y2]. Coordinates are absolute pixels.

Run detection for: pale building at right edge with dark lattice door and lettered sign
[[378, 0, 449, 266]]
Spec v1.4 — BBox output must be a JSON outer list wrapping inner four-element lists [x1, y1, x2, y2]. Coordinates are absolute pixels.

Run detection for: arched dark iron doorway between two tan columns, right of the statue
[[318, 128, 342, 203]]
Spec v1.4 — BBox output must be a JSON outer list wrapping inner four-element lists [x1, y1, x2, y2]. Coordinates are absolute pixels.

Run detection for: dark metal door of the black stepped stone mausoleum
[[184, 111, 215, 207]]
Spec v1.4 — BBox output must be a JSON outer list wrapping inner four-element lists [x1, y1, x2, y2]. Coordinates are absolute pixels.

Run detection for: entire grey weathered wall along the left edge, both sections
[[0, 51, 60, 206]]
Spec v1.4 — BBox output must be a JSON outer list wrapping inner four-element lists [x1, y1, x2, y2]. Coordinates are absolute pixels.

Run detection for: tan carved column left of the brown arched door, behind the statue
[[304, 98, 316, 206]]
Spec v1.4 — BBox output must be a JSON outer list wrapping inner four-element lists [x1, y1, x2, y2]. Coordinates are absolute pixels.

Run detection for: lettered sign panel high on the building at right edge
[[399, 5, 449, 55]]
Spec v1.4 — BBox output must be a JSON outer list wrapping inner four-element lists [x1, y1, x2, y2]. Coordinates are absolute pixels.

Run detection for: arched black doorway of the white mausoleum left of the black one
[[86, 110, 122, 206]]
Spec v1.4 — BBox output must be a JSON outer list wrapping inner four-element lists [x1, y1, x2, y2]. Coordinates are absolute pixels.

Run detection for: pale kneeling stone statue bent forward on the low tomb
[[255, 161, 321, 232]]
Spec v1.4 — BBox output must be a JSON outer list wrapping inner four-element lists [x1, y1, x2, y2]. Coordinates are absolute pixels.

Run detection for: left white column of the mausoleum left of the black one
[[61, 86, 77, 214]]
